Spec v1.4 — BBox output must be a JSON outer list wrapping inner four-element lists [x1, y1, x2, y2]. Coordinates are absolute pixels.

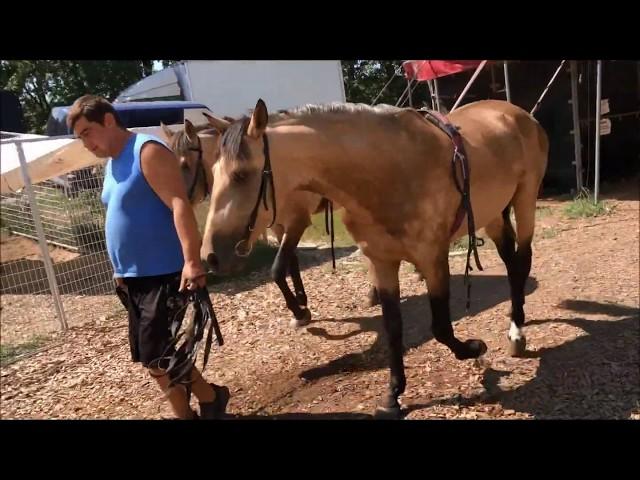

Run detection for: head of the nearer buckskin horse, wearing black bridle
[[201, 100, 275, 274]]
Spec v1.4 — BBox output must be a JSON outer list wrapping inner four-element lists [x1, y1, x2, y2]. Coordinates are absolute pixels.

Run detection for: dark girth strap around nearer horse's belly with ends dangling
[[420, 110, 484, 310]]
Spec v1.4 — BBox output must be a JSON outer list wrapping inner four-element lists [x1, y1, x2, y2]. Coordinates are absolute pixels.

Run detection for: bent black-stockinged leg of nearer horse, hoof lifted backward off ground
[[419, 248, 487, 360]]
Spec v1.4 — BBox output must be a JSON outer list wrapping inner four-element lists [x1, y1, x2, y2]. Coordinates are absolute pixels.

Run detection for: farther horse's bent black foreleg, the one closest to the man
[[271, 226, 311, 327]]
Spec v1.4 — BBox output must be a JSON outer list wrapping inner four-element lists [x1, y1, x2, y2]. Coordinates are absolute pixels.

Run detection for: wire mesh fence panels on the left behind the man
[[0, 163, 121, 343]]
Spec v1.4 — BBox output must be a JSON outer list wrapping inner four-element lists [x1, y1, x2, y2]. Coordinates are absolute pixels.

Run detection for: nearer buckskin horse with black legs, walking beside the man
[[201, 100, 548, 418]]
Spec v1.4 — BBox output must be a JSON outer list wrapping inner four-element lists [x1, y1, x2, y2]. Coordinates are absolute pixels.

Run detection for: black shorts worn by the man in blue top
[[117, 272, 186, 368]]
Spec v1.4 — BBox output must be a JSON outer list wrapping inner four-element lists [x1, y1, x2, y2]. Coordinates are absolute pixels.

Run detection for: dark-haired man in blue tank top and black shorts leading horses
[[67, 95, 229, 419]]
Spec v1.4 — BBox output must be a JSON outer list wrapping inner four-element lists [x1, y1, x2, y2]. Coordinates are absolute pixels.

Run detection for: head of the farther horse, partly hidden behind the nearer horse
[[161, 119, 220, 206]]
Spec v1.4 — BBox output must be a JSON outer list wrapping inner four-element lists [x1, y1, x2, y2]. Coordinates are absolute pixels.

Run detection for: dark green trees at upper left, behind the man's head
[[0, 60, 153, 133]]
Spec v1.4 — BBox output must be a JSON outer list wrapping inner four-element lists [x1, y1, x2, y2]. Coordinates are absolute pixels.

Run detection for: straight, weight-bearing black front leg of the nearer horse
[[370, 260, 407, 419]]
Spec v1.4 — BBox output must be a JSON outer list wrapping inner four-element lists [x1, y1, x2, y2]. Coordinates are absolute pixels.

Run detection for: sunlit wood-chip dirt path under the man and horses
[[1, 184, 640, 419]]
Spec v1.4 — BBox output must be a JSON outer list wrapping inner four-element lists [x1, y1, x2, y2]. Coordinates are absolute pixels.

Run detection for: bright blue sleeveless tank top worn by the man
[[102, 134, 184, 277]]
